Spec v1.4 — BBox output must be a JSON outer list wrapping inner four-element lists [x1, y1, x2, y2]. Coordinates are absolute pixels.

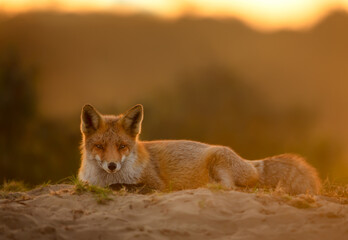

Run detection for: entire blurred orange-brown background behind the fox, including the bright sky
[[0, 0, 348, 184]]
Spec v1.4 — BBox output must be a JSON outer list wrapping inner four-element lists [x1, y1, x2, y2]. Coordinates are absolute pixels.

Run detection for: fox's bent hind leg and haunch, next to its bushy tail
[[206, 146, 258, 189]]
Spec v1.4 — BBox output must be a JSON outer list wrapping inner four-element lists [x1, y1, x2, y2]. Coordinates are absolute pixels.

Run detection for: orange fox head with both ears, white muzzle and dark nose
[[81, 104, 144, 173]]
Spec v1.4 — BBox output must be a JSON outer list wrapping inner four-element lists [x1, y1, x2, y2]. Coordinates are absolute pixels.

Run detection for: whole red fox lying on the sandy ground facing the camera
[[78, 104, 320, 194]]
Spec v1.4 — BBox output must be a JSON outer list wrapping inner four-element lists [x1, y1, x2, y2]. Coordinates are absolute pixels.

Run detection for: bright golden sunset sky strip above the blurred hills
[[0, 0, 348, 30]]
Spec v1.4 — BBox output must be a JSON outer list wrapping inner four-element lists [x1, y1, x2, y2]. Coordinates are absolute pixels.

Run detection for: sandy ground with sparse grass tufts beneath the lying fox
[[0, 185, 348, 240]]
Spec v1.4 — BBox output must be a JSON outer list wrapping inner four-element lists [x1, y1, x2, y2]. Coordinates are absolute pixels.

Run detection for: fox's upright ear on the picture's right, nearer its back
[[122, 104, 144, 137]]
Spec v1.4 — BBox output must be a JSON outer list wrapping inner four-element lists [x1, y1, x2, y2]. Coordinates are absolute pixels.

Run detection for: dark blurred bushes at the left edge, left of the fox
[[0, 50, 79, 184]]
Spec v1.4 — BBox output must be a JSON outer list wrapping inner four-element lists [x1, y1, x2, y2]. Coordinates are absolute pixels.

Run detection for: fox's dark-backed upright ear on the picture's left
[[81, 104, 102, 134]]
